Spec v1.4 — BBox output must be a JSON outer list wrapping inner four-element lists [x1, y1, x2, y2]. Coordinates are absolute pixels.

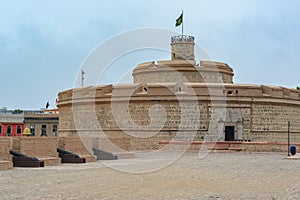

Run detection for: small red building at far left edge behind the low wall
[[0, 113, 24, 136]]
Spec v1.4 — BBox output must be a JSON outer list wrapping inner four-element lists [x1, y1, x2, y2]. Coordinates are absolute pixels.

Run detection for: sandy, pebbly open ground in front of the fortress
[[0, 152, 300, 199]]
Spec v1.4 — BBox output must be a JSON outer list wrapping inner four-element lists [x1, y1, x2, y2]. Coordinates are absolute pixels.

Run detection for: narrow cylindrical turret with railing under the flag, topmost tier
[[171, 35, 195, 60]]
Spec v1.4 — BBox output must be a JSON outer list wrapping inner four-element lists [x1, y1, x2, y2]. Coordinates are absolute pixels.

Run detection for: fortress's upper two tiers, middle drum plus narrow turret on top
[[132, 35, 234, 83]]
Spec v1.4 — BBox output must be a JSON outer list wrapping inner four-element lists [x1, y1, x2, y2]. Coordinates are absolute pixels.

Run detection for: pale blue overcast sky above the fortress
[[0, 0, 300, 109]]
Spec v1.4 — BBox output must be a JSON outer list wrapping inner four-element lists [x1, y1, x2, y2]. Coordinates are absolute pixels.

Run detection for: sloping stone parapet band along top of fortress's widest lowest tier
[[58, 83, 300, 106]]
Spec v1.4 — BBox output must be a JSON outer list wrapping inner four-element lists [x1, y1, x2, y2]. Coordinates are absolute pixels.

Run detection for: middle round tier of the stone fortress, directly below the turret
[[133, 61, 233, 83]]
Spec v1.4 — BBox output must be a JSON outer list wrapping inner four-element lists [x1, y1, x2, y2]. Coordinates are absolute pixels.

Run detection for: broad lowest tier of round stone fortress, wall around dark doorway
[[58, 83, 300, 149]]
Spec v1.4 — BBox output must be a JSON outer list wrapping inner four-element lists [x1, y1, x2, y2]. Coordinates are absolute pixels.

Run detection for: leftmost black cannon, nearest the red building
[[9, 150, 45, 167]]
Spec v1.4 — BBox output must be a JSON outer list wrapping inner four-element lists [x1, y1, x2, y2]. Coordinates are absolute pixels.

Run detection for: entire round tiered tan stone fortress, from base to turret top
[[58, 35, 300, 150]]
